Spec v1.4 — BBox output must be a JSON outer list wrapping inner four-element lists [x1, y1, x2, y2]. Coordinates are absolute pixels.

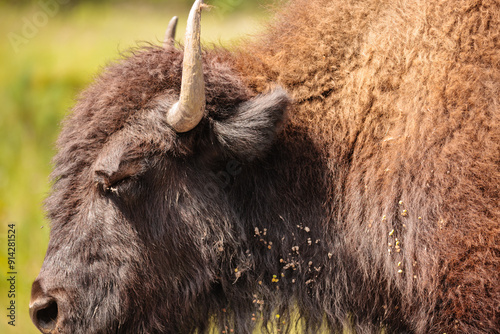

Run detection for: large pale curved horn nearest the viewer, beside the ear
[[167, 0, 205, 132]]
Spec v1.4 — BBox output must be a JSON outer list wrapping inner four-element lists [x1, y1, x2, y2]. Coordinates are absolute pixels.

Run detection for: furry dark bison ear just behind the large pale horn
[[214, 87, 291, 161]]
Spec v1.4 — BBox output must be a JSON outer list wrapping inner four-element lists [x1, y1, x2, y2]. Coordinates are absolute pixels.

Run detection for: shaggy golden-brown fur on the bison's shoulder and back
[[235, 0, 500, 333]]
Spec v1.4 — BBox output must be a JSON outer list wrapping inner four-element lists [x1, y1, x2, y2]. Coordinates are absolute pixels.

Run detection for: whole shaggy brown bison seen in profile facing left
[[30, 0, 500, 334]]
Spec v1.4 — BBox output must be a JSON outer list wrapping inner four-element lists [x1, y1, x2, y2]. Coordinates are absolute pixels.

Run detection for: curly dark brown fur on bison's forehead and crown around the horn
[[46, 46, 250, 222]]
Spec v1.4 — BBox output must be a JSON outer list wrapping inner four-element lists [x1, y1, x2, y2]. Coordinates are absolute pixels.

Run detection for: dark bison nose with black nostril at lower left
[[30, 279, 61, 333]]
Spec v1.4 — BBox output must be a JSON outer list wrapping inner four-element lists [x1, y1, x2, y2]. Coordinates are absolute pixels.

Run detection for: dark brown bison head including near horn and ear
[[30, 0, 289, 333]]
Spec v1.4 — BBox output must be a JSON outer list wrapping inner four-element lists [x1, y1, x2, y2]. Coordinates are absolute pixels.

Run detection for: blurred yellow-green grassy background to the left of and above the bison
[[0, 0, 269, 334]]
